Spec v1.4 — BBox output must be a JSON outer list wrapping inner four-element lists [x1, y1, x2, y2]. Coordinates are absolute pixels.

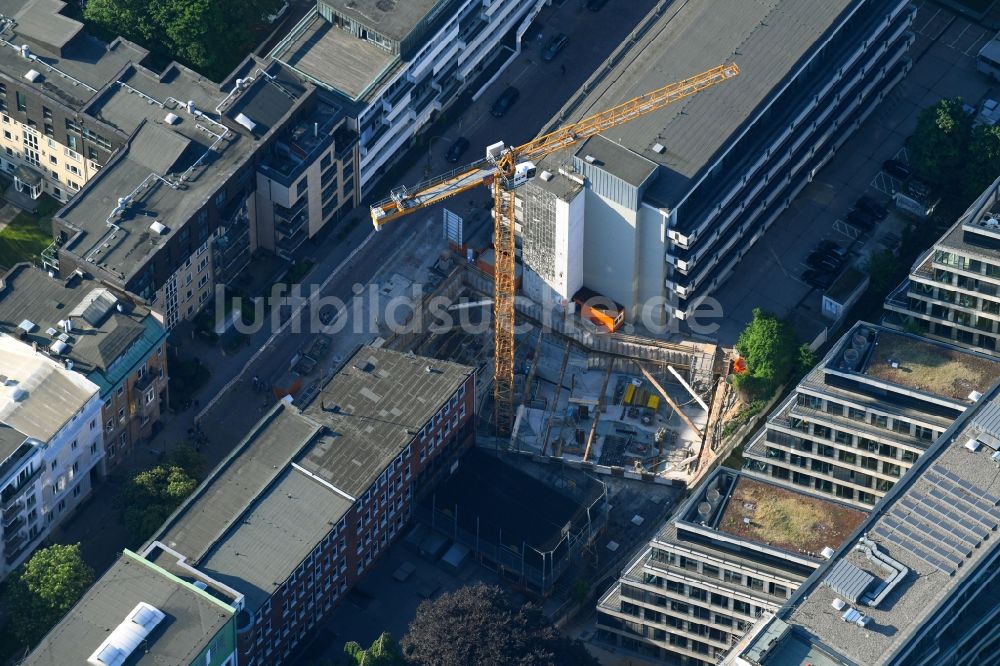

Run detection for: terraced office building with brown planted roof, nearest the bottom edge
[[597, 468, 865, 666]]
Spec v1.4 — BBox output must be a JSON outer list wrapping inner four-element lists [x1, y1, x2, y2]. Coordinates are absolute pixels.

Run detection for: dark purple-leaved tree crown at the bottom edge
[[402, 583, 598, 666]]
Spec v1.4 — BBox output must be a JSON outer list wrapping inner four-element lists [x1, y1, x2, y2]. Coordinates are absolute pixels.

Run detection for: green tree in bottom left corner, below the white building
[[5, 543, 94, 645]]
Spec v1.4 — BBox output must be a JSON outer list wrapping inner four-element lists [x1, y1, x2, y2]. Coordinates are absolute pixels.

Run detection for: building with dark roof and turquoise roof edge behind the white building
[[0, 264, 168, 474]]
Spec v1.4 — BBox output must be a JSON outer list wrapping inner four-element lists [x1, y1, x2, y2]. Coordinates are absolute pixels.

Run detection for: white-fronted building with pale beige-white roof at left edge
[[0, 332, 104, 580]]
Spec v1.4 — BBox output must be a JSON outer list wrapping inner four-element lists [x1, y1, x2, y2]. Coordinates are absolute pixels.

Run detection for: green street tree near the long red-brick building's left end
[[117, 465, 198, 542]]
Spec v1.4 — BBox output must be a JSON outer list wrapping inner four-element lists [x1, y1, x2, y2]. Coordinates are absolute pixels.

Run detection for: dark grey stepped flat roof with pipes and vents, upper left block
[[58, 64, 258, 282]]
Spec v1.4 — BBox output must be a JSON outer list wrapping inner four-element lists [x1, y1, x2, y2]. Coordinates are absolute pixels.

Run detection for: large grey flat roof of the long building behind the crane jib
[[555, 0, 857, 208]]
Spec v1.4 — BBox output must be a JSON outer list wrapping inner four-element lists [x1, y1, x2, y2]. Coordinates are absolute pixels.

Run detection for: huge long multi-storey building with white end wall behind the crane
[[520, 0, 916, 324]]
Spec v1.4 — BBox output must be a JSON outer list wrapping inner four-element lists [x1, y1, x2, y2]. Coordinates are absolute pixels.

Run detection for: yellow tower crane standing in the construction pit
[[371, 63, 740, 434]]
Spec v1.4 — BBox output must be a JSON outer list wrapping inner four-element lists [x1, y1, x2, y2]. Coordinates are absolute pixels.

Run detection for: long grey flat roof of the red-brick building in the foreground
[[150, 347, 472, 608]]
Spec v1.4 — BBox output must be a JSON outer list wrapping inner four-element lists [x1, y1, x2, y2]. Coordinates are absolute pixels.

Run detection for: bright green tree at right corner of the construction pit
[[733, 308, 798, 399]]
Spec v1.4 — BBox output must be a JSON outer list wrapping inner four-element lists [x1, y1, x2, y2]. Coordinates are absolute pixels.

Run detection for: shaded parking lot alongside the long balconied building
[[715, 0, 1000, 345]]
